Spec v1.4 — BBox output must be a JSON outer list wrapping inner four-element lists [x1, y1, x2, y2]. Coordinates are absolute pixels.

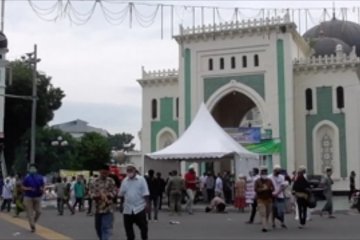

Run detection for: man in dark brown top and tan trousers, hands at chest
[[255, 167, 275, 232]]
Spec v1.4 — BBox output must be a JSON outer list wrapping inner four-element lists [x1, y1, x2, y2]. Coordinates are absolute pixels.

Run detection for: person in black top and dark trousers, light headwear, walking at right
[[293, 168, 310, 229]]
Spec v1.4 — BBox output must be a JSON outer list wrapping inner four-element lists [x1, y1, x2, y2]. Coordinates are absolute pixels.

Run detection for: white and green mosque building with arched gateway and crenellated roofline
[[138, 15, 360, 189]]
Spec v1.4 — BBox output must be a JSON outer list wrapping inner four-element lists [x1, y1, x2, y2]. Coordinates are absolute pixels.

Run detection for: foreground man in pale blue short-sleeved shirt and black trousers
[[119, 164, 150, 240]]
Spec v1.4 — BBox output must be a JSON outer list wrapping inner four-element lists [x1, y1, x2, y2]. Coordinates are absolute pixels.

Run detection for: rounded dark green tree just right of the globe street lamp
[[78, 132, 111, 171]]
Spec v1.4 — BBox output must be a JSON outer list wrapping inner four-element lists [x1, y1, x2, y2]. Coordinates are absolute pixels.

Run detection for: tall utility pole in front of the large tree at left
[[25, 44, 40, 164]]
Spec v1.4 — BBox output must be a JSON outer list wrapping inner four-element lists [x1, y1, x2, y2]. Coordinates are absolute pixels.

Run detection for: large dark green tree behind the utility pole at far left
[[4, 60, 65, 172]]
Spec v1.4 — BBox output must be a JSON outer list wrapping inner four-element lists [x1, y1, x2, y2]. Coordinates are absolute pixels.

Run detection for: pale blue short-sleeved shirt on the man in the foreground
[[119, 175, 150, 214]]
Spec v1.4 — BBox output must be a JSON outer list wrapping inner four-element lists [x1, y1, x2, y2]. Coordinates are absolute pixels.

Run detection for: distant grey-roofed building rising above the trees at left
[[52, 119, 109, 139]]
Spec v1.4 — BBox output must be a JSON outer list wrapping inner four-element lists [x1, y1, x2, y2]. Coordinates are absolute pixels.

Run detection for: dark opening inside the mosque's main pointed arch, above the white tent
[[207, 90, 263, 172]]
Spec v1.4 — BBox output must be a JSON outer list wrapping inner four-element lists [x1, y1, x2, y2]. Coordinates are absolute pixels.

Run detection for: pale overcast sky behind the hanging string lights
[[4, 0, 360, 147]]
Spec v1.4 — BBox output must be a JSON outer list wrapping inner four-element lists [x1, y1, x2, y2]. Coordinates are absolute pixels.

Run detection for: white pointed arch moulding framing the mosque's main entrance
[[206, 80, 269, 126]]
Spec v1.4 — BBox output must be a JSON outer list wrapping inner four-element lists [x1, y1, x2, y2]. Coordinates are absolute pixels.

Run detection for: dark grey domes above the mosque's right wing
[[303, 18, 360, 56]]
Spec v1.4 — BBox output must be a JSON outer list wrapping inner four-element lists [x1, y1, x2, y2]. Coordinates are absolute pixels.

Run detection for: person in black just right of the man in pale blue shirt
[[146, 169, 161, 221]]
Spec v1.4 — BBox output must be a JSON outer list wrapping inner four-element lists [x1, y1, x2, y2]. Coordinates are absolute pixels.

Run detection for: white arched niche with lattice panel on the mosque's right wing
[[312, 120, 341, 179]]
